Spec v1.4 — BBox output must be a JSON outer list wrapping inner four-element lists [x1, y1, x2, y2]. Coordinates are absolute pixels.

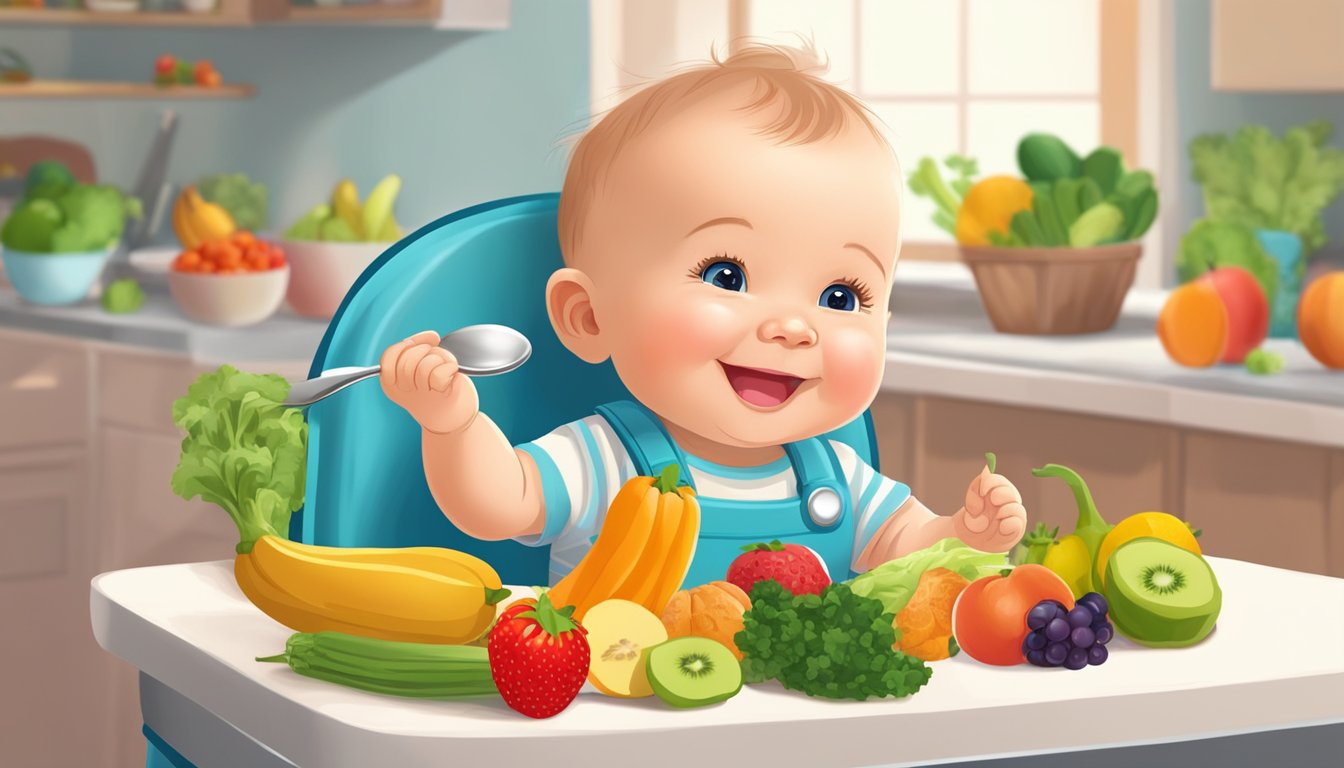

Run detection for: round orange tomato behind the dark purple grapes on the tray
[[952, 564, 1074, 667]]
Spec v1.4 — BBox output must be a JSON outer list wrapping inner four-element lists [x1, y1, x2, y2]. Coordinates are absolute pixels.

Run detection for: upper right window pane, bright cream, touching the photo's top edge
[[966, 0, 1101, 95]]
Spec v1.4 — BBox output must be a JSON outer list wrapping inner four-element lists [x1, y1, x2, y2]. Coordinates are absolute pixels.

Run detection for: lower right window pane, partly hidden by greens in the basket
[[966, 100, 1101, 175]]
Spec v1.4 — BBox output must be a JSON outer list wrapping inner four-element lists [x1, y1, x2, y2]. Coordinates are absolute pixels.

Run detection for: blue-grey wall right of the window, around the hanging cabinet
[[1173, 0, 1344, 258]]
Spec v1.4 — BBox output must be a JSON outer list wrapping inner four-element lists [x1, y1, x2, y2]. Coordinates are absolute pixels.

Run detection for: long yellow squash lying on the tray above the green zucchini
[[234, 535, 508, 644]]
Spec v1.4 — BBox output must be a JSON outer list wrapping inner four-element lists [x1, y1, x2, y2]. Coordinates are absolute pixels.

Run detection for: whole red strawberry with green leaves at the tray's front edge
[[487, 594, 591, 718]]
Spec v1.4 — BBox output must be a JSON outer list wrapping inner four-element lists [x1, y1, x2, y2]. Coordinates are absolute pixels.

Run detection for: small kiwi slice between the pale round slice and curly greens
[[646, 638, 742, 707]]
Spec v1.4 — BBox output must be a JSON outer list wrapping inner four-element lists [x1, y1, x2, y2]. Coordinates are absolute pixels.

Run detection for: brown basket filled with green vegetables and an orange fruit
[[910, 133, 1157, 335]]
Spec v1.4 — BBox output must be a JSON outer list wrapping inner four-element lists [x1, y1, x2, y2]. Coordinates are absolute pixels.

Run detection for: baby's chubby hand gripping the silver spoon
[[378, 331, 480, 434]]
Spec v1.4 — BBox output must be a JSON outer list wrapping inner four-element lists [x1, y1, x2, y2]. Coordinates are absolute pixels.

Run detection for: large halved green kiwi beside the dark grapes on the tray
[[1105, 537, 1223, 647]]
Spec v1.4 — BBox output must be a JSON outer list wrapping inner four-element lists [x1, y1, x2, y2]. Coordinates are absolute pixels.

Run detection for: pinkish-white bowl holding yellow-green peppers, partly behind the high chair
[[280, 239, 392, 320]]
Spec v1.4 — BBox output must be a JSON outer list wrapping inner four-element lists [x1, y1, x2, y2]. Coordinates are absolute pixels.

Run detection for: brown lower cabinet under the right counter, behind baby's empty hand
[[872, 393, 1344, 576]]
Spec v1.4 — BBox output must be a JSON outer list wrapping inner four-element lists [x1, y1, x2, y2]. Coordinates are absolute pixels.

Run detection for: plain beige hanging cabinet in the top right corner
[[1211, 0, 1344, 91]]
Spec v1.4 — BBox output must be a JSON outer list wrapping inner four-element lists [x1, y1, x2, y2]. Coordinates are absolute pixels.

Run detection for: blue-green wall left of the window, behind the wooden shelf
[[0, 0, 589, 238]]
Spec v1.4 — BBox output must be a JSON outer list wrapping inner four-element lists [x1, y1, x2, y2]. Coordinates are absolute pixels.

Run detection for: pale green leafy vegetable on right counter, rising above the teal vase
[[1189, 120, 1344, 253]]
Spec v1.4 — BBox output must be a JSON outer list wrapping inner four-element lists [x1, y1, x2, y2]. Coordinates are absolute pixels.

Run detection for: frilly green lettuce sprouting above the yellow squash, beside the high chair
[[172, 366, 308, 553]]
